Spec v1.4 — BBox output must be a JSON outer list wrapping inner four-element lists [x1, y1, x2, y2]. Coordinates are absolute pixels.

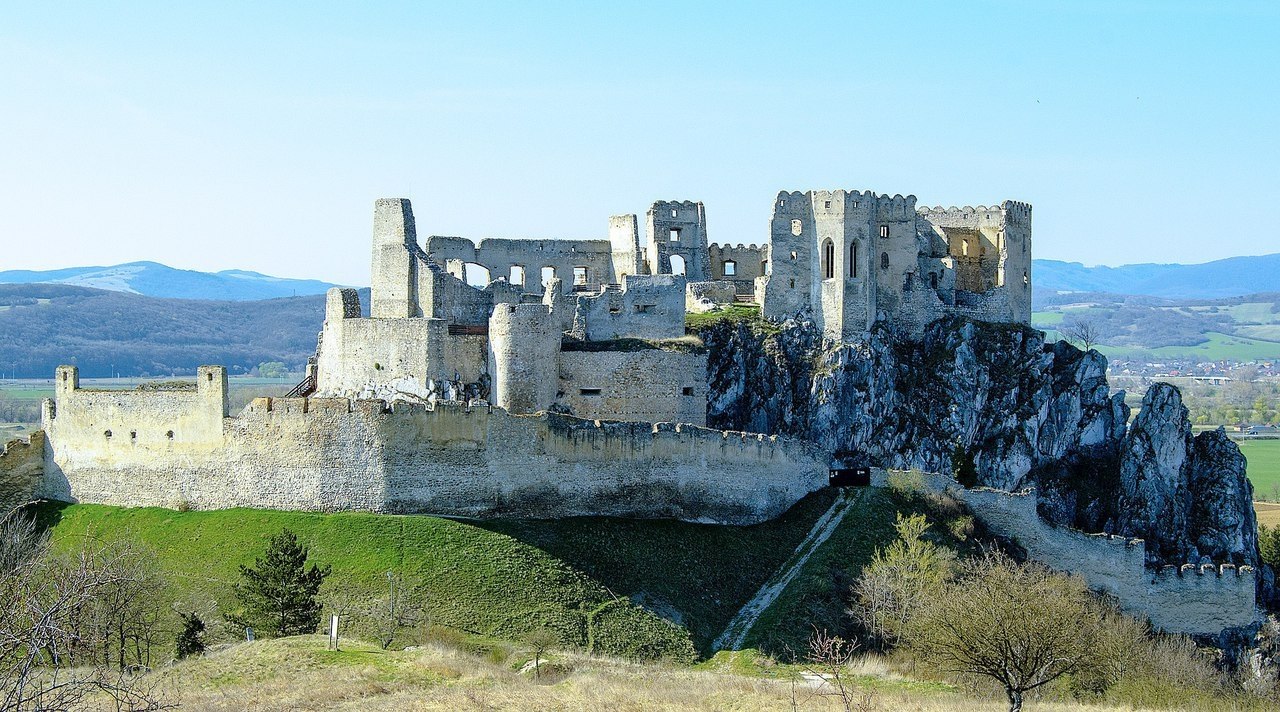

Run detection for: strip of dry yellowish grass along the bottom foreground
[[74, 636, 1213, 712]]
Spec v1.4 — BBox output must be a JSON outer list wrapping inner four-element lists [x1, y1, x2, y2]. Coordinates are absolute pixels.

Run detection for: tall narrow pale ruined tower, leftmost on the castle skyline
[[369, 197, 422, 319]]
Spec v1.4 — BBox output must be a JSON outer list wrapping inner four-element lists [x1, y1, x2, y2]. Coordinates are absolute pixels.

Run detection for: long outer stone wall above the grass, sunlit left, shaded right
[[38, 393, 828, 524]]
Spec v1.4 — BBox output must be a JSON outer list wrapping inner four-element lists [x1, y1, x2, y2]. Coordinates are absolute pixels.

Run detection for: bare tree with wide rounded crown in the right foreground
[[909, 552, 1106, 712]]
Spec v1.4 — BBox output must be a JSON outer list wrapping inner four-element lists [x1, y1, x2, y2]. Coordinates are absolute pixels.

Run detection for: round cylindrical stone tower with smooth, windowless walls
[[489, 303, 563, 414]]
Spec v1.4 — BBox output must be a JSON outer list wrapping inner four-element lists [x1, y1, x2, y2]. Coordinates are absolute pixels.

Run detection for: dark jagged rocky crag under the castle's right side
[[700, 313, 1258, 566]]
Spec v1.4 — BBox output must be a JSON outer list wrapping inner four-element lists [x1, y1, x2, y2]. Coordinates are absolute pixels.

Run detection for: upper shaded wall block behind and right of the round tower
[[571, 274, 685, 341]]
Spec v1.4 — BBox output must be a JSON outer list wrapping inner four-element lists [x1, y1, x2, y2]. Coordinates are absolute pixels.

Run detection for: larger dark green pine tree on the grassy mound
[[228, 529, 332, 636]]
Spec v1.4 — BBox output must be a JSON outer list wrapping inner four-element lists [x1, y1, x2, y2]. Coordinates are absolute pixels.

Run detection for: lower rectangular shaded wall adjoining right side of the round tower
[[558, 348, 707, 425]]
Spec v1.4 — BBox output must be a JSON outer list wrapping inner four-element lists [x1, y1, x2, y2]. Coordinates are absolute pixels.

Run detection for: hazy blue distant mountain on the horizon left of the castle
[[0, 263, 333, 301]]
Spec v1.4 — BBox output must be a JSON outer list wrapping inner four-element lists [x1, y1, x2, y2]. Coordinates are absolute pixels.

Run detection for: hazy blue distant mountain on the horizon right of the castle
[[1032, 254, 1280, 300]]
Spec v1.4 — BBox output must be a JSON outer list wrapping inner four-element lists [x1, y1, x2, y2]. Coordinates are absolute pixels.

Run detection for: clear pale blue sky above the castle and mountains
[[0, 0, 1280, 284]]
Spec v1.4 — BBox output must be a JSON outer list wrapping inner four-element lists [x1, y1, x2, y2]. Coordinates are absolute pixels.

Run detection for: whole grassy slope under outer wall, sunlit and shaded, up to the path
[[30, 490, 844, 659]]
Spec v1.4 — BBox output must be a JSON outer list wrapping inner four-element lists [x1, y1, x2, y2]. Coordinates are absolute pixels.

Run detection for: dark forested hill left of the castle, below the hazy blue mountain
[[0, 284, 369, 378]]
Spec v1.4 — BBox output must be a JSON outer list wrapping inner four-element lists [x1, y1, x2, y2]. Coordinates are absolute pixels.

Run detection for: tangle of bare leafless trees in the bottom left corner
[[0, 516, 170, 711]]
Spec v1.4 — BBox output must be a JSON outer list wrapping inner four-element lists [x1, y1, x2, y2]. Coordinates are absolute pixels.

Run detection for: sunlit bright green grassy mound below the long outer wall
[[32, 505, 694, 661]]
